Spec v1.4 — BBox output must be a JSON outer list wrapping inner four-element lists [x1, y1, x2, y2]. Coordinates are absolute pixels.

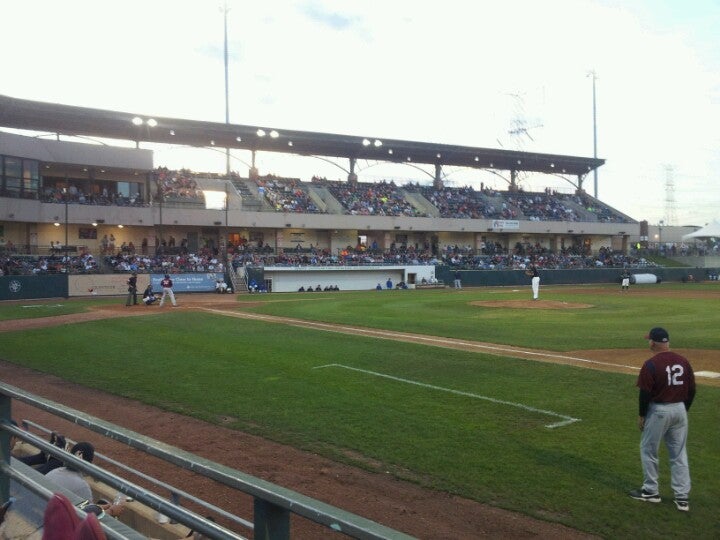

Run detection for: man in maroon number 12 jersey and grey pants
[[630, 328, 695, 512]]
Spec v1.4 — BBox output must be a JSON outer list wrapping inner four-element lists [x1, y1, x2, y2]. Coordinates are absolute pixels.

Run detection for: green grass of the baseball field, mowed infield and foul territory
[[0, 283, 720, 539]]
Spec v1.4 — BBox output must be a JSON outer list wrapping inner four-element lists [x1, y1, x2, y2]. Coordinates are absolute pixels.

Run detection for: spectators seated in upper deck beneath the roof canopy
[[33, 167, 630, 223]]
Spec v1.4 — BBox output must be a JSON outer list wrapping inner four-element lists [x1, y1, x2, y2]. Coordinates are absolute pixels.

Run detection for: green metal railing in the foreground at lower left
[[0, 383, 411, 540]]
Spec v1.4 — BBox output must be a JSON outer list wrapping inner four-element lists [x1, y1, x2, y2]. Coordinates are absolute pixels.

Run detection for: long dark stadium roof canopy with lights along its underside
[[0, 95, 605, 178]]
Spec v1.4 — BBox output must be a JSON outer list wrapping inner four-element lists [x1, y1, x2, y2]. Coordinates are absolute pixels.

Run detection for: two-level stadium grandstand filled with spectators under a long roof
[[0, 96, 640, 296]]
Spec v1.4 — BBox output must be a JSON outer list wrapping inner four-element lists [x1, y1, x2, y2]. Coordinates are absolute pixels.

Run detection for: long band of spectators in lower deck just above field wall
[[0, 236, 720, 275]]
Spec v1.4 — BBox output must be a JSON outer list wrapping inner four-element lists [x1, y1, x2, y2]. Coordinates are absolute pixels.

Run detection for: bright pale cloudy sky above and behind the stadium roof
[[0, 0, 720, 225]]
